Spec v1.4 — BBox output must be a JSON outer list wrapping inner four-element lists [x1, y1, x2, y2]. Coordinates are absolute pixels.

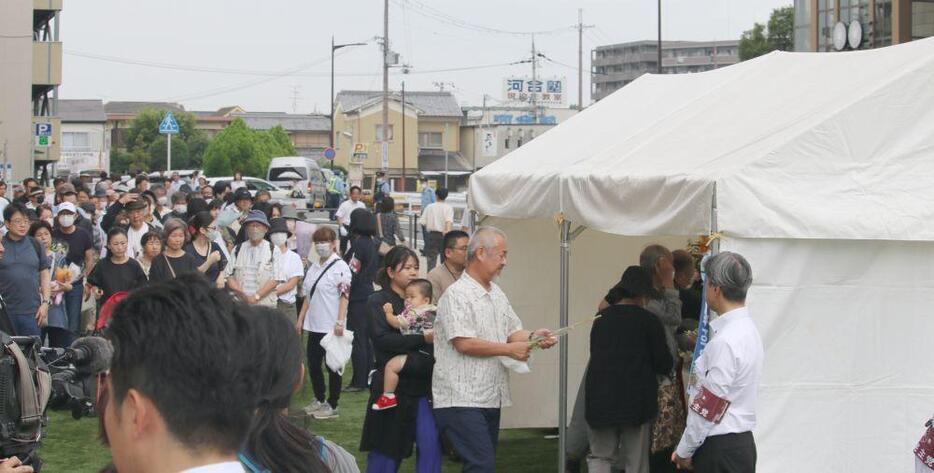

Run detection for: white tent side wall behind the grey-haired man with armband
[[721, 238, 934, 473]]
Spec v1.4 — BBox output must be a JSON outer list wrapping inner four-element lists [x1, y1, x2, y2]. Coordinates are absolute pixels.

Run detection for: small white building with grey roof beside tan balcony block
[[56, 99, 110, 174]]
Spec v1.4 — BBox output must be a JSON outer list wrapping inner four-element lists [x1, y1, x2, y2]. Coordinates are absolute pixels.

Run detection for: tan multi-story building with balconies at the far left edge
[[0, 0, 62, 180]]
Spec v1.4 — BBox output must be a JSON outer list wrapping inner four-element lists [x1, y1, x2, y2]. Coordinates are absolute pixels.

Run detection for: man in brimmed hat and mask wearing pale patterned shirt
[[227, 210, 278, 307]]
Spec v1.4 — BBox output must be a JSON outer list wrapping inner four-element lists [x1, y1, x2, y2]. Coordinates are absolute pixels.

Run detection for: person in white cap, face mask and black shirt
[[52, 202, 94, 346]]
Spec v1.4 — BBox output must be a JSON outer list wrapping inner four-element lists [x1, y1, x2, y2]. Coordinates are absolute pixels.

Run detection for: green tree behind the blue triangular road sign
[[111, 108, 208, 173]]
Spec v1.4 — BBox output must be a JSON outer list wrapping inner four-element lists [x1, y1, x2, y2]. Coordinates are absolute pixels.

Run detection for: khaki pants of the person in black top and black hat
[[587, 422, 651, 473]]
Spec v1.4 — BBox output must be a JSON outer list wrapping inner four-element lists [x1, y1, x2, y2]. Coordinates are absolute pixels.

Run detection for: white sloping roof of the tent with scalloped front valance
[[470, 39, 934, 240]]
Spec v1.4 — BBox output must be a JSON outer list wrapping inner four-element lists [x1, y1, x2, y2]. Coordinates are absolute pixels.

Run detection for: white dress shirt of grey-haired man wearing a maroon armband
[[677, 307, 764, 458]]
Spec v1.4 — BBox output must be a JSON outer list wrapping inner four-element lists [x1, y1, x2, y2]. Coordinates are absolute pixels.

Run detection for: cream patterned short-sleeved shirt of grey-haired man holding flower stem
[[431, 272, 522, 408]]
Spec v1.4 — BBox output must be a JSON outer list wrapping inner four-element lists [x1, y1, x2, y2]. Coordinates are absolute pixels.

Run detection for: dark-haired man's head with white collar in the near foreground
[[101, 275, 262, 473]]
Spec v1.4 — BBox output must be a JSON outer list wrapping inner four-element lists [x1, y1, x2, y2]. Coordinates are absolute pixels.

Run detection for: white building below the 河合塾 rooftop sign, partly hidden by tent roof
[[461, 107, 577, 170]]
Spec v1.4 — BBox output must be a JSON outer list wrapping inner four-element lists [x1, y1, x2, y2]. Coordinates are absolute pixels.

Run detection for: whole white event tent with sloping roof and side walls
[[470, 39, 934, 473]]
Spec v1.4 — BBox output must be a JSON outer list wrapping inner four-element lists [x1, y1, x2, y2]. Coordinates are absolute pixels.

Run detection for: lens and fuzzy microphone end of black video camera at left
[[40, 337, 113, 420]]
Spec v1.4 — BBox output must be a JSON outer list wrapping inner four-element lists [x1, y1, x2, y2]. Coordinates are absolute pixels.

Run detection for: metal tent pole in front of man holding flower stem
[[558, 220, 571, 472]]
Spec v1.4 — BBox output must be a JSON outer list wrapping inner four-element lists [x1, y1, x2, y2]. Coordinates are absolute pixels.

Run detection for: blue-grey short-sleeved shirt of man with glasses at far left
[[0, 234, 51, 314]]
